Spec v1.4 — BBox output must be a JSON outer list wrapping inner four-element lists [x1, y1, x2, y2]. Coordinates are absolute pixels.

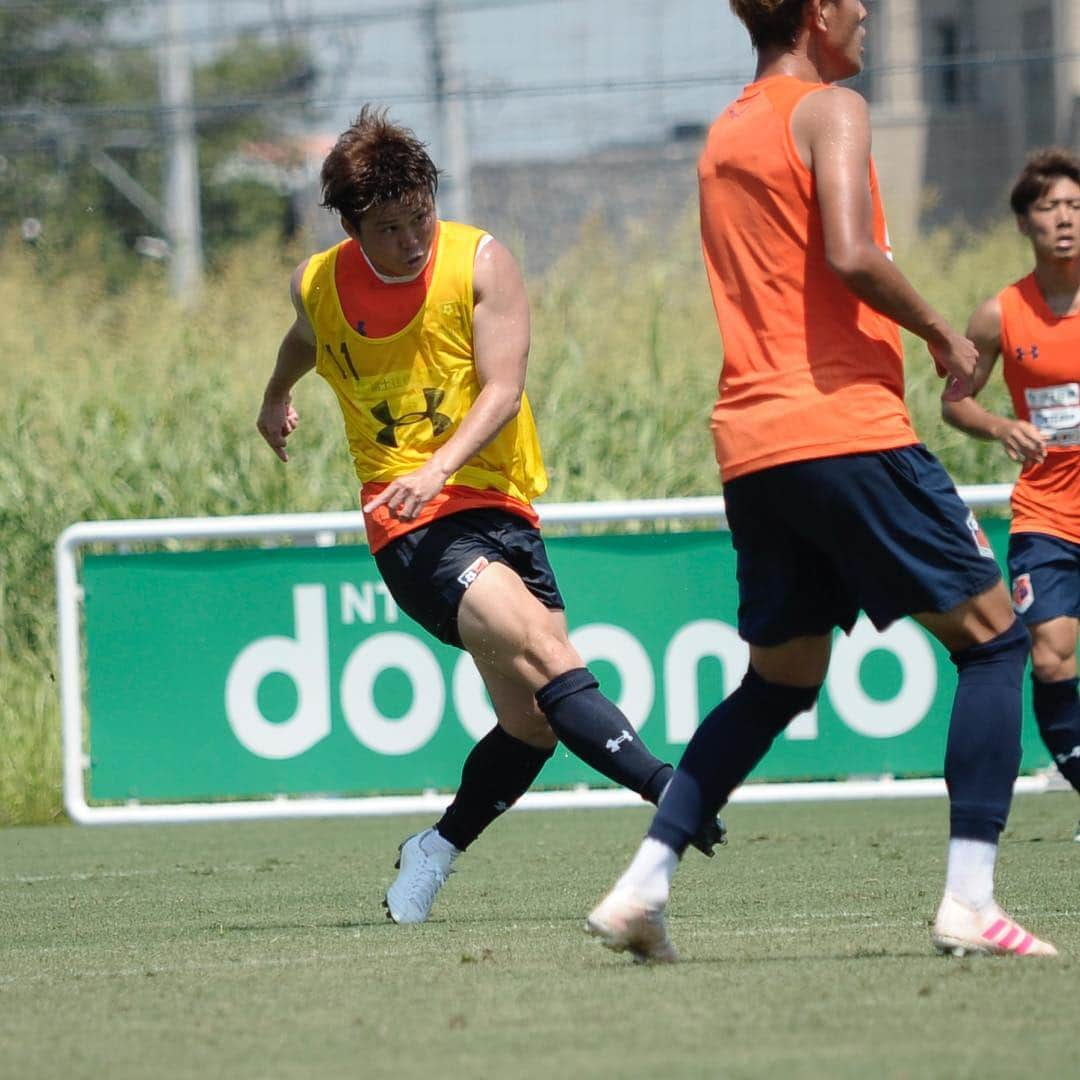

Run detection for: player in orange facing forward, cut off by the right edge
[[942, 148, 1080, 840]]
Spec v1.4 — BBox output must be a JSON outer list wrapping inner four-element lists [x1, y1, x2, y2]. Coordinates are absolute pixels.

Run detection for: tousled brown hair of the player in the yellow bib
[[320, 105, 438, 228]]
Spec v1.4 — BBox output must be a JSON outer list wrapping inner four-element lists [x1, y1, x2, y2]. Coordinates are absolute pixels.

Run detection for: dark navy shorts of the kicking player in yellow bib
[[375, 510, 566, 649]]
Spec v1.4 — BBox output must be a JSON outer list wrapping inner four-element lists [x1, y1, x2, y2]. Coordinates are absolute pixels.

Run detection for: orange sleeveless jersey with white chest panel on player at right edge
[[998, 274, 1080, 543]]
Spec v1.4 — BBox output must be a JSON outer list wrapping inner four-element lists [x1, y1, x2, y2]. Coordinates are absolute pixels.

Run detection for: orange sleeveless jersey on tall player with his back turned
[[698, 76, 917, 481]]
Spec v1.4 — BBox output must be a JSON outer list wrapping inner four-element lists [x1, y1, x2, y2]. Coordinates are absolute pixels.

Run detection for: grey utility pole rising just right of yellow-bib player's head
[[424, 0, 472, 222]]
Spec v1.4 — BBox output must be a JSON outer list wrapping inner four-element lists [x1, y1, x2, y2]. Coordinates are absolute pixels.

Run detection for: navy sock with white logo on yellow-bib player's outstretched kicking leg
[[537, 667, 672, 804]]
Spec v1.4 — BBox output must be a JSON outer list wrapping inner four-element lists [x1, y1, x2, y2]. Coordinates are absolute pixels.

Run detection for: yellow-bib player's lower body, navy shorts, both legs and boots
[[376, 511, 724, 922]]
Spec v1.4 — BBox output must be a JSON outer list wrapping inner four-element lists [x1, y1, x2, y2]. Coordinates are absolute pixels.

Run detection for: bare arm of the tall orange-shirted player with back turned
[[792, 87, 976, 400]]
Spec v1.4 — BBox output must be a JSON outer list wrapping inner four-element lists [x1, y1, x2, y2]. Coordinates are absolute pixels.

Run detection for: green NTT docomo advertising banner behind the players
[[82, 521, 1049, 804]]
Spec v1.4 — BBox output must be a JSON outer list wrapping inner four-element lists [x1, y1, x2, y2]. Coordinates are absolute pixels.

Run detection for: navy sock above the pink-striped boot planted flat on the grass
[[945, 621, 1031, 843]]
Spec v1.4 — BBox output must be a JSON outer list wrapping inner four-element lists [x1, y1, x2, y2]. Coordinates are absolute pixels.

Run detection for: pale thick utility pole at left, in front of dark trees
[[161, 0, 203, 300]]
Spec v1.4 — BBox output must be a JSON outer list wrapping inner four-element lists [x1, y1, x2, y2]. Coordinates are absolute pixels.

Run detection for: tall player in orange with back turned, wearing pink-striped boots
[[586, 0, 1055, 961]]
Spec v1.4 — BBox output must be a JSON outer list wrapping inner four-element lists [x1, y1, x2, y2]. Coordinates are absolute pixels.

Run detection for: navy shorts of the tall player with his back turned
[[724, 444, 1001, 646]]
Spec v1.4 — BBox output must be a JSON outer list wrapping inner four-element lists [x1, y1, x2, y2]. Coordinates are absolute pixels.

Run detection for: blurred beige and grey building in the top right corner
[[864, 0, 1080, 237]]
